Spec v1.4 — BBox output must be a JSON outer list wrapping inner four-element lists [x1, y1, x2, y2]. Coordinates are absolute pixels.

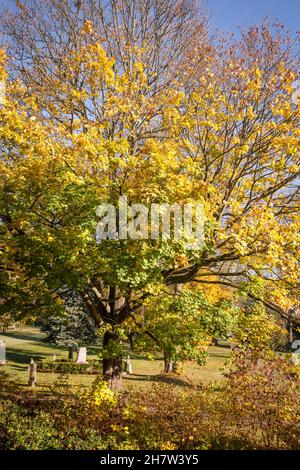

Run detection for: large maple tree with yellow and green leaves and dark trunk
[[0, 0, 300, 375]]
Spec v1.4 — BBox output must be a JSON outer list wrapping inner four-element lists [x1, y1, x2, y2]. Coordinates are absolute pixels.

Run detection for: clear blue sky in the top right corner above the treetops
[[202, 0, 300, 35]]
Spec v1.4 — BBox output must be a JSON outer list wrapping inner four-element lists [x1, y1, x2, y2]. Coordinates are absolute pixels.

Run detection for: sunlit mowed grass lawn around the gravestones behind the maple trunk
[[0, 328, 230, 389]]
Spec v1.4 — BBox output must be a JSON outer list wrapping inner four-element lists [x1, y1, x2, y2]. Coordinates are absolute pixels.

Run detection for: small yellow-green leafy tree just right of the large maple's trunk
[[134, 289, 235, 373]]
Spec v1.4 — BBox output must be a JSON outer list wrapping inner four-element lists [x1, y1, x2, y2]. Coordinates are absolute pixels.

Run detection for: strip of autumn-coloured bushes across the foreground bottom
[[0, 353, 300, 450]]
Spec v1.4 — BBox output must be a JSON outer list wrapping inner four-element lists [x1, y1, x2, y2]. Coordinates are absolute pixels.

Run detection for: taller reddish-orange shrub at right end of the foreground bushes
[[224, 351, 300, 449]]
